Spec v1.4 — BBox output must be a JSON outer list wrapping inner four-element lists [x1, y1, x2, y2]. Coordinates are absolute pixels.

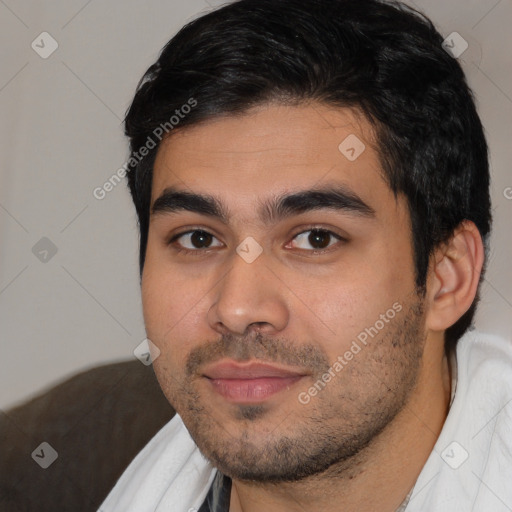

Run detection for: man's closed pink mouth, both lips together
[[203, 361, 306, 404]]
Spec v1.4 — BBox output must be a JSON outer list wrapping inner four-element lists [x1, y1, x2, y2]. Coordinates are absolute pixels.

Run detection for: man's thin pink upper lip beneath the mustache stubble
[[203, 361, 305, 379]]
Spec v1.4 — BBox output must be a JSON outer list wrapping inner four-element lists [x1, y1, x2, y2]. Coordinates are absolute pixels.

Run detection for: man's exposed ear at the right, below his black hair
[[426, 220, 484, 331]]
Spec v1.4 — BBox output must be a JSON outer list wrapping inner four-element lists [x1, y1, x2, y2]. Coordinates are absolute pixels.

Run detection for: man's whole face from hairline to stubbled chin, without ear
[[142, 104, 425, 482]]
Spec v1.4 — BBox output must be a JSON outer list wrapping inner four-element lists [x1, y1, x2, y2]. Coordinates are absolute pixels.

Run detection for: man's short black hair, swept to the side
[[125, 0, 491, 350]]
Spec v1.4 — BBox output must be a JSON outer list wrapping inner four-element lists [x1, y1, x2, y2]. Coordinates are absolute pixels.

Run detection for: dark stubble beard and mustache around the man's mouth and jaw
[[157, 299, 425, 483]]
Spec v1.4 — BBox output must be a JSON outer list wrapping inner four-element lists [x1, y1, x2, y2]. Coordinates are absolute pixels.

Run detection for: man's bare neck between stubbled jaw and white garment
[[230, 344, 451, 512]]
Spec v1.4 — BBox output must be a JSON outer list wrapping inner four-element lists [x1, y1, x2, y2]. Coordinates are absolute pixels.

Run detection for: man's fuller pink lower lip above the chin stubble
[[209, 376, 302, 403]]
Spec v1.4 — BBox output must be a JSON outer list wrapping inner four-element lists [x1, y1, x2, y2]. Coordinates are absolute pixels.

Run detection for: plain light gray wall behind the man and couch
[[0, 0, 512, 408]]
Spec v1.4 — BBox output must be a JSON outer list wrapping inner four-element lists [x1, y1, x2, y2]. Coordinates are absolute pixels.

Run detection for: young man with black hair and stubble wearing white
[[101, 0, 512, 512]]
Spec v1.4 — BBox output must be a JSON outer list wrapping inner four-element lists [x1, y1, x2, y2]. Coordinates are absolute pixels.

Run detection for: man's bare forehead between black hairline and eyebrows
[[152, 104, 394, 222]]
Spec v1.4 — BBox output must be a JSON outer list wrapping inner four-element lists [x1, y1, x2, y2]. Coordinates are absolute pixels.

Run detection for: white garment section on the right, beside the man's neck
[[406, 331, 512, 512]]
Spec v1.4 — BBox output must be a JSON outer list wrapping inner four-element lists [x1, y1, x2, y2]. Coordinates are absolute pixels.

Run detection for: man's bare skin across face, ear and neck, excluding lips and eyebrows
[[142, 103, 483, 512]]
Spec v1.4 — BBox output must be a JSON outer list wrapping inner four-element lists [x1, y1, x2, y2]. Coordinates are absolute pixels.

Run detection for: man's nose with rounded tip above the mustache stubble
[[208, 248, 289, 335]]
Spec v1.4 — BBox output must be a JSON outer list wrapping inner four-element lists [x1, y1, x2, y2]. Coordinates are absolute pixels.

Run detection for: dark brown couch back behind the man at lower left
[[0, 360, 175, 512]]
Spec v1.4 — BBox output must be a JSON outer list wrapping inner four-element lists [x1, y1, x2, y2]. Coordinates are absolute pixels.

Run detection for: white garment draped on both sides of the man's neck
[[99, 331, 512, 512]]
